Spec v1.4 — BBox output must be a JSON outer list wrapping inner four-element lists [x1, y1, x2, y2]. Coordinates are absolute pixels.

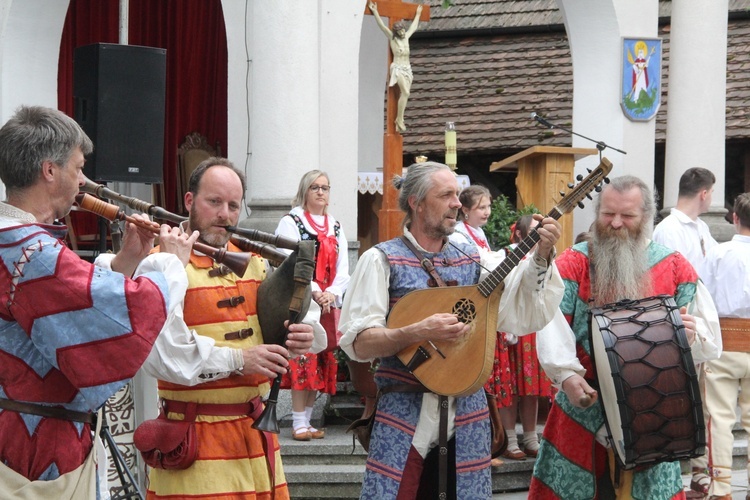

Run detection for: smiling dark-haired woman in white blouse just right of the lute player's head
[[450, 184, 513, 467]]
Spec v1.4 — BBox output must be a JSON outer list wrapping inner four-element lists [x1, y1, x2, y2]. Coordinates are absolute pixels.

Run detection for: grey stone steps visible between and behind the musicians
[[277, 383, 747, 499]]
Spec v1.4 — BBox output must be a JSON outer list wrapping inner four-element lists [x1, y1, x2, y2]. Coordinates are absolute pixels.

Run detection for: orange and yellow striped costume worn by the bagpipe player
[[148, 243, 289, 500]]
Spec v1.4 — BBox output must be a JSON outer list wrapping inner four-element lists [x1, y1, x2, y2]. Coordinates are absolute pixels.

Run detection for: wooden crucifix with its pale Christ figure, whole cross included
[[365, 0, 430, 241]]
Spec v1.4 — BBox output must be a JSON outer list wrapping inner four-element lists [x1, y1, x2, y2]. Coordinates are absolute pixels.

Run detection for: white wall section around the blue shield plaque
[[557, 0, 658, 234]]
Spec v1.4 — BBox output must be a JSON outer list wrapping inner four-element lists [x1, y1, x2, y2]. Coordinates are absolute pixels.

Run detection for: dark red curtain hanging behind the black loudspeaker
[[58, 0, 227, 219]]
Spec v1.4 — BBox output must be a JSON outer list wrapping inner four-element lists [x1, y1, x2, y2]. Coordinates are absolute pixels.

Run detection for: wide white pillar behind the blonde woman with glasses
[[222, 0, 364, 240]]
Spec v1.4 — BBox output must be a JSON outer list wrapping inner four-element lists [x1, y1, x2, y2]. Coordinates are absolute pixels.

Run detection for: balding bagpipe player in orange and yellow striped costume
[[144, 158, 325, 499]]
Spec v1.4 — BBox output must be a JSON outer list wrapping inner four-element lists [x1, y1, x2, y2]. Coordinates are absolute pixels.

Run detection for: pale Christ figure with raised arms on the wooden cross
[[368, 2, 422, 133]]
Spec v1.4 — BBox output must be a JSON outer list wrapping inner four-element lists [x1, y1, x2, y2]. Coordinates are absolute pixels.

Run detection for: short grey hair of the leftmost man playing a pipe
[[0, 106, 94, 191]]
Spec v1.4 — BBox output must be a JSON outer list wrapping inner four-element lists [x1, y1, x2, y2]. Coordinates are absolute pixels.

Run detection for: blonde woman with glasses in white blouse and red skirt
[[276, 170, 349, 441]]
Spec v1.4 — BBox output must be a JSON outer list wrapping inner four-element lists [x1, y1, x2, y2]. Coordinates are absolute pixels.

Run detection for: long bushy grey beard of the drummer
[[591, 223, 651, 307]]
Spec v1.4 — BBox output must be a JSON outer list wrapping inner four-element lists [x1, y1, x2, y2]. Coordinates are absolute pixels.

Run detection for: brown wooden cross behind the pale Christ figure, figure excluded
[[365, 0, 430, 241]]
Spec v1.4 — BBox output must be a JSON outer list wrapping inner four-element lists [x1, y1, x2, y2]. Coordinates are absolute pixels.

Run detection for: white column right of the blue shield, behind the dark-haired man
[[664, 0, 734, 241]]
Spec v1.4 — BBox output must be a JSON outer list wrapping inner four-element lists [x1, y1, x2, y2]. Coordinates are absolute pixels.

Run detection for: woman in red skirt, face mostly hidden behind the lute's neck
[[500, 215, 552, 460]]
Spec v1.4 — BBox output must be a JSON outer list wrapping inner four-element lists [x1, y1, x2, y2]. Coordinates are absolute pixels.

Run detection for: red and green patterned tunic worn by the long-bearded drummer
[[529, 242, 698, 500]]
